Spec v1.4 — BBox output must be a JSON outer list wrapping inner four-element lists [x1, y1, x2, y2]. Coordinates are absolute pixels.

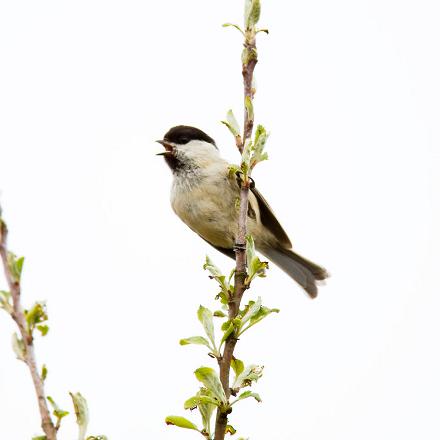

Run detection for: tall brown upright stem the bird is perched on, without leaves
[[214, 24, 258, 440]]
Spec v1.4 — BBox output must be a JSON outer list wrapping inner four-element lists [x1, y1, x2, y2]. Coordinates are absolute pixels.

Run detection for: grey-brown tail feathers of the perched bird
[[260, 247, 329, 298]]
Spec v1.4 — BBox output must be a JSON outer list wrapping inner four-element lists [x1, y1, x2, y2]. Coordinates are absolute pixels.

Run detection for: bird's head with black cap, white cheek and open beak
[[157, 125, 219, 174]]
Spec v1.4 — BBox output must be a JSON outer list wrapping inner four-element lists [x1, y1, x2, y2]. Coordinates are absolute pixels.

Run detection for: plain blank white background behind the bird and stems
[[0, 0, 440, 440]]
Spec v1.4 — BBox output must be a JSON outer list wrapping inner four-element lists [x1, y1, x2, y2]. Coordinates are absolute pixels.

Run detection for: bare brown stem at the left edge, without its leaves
[[0, 219, 57, 440]]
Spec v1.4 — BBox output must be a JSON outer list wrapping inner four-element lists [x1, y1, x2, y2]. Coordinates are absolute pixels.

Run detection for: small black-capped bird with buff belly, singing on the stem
[[157, 125, 328, 298]]
